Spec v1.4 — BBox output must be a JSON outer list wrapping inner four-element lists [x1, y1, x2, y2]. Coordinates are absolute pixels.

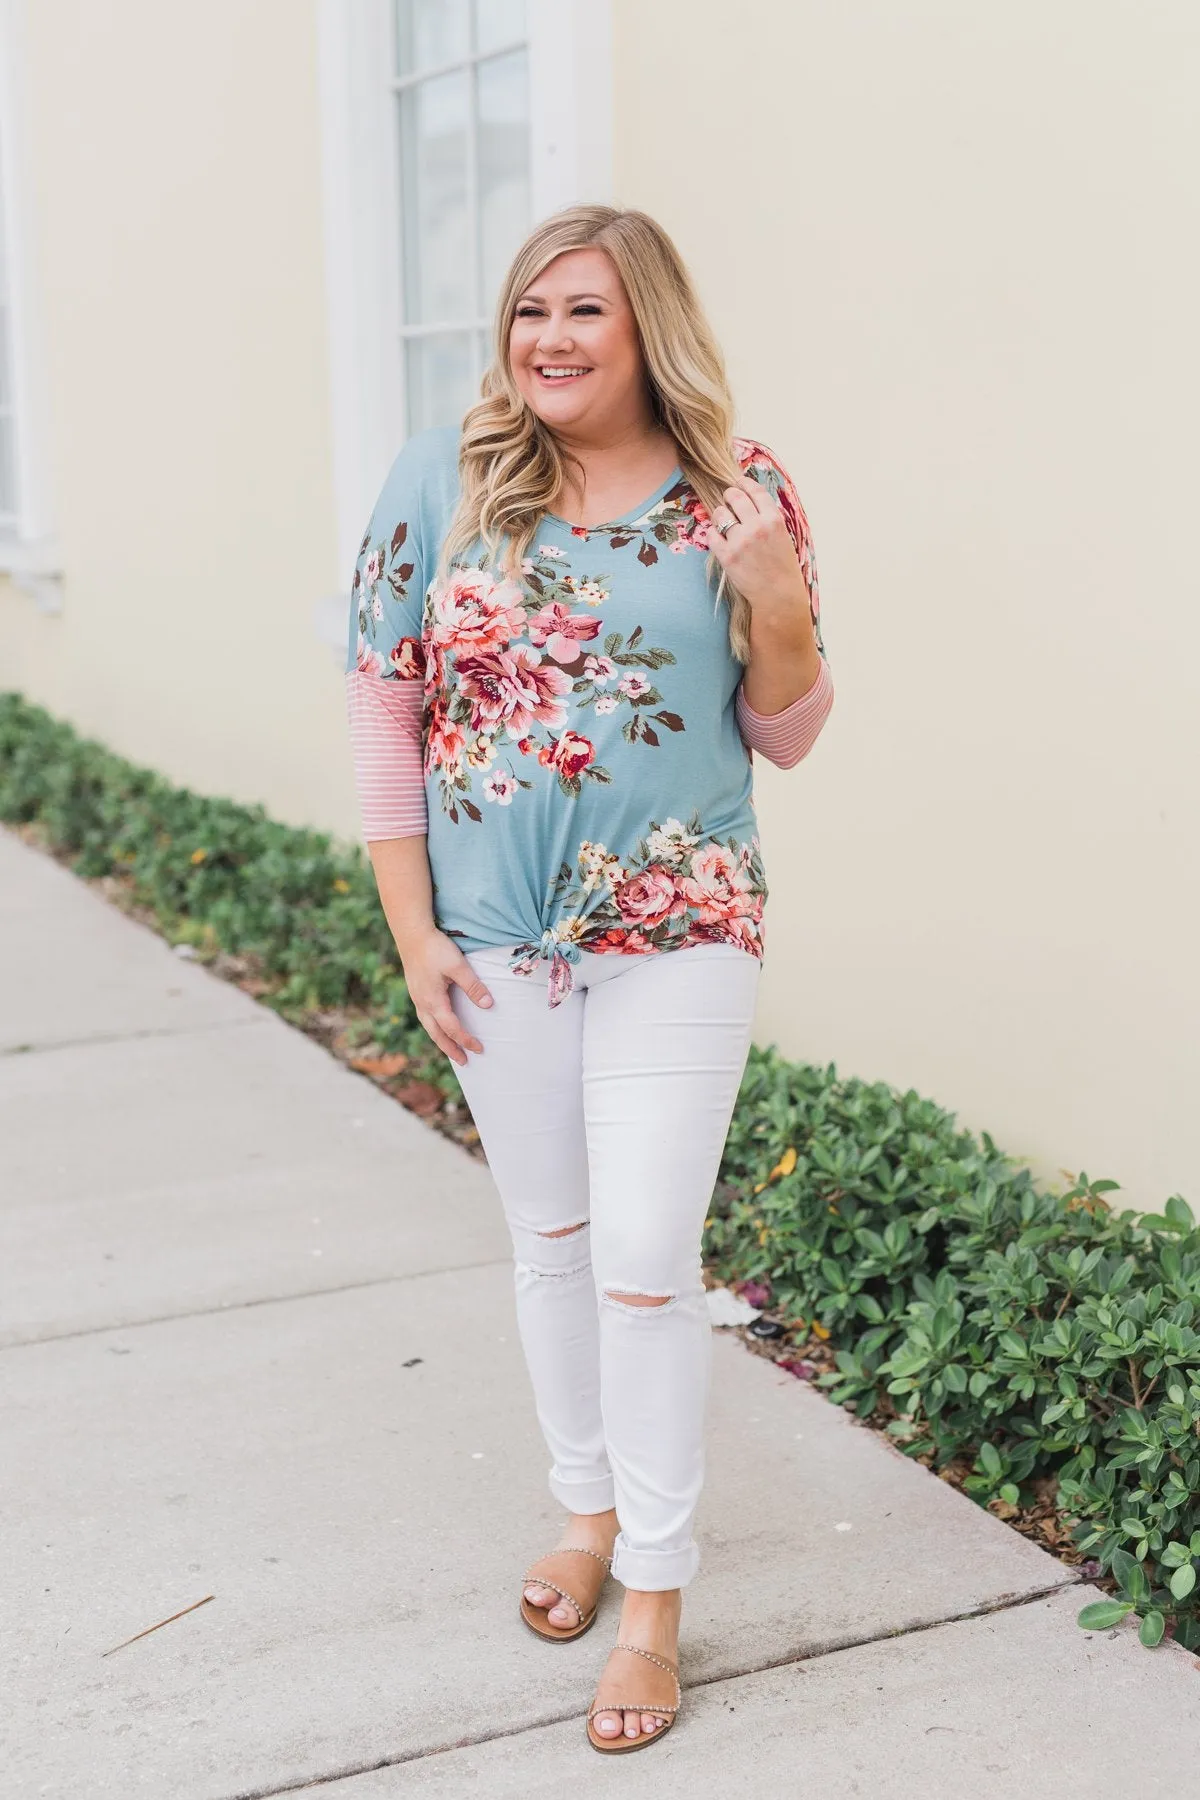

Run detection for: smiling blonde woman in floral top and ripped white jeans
[[347, 207, 833, 1751]]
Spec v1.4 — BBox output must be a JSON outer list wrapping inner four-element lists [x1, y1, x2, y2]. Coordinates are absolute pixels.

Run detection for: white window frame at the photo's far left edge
[[0, 0, 63, 612]]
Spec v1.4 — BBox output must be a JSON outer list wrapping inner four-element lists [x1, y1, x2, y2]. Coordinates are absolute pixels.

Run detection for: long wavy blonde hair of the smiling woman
[[441, 207, 750, 662]]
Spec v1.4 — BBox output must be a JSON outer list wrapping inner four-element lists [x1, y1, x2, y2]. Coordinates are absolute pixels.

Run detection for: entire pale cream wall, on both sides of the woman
[[0, 0, 1200, 1204]]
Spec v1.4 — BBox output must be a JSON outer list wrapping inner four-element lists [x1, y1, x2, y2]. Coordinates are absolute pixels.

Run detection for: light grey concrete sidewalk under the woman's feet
[[0, 832, 1200, 1800]]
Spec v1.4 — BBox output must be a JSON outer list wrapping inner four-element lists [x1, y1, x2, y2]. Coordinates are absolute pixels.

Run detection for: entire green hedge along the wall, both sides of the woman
[[0, 695, 1200, 1649]]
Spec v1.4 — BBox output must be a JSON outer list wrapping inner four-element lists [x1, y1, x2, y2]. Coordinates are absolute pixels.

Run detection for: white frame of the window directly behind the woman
[[318, 0, 612, 619]]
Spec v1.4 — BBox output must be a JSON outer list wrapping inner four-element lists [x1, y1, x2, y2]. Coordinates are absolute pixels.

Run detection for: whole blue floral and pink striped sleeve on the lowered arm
[[345, 441, 428, 842]]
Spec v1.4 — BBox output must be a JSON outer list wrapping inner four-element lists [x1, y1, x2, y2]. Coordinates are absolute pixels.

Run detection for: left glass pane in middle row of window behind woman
[[399, 70, 475, 324]]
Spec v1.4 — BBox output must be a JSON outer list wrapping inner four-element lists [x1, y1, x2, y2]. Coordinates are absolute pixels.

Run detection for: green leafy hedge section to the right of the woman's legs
[[707, 1049, 1200, 1647]]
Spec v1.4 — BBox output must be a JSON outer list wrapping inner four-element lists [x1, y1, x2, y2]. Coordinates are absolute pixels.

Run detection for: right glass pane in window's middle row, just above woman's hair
[[479, 50, 531, 313]]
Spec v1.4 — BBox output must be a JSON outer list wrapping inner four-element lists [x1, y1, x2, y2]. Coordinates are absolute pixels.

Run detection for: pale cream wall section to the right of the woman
[[615, 0, 1200, 1204]]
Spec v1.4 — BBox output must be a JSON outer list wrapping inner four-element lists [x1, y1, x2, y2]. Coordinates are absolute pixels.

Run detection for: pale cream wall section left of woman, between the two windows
[[0, 0, 354, 830]]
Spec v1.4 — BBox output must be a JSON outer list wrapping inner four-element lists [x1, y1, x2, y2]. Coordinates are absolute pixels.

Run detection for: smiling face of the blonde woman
[[509, 250, 649, 437]]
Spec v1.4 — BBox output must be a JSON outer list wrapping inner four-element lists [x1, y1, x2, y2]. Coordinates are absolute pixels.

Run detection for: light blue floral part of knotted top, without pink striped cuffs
[[347, 430, 826, 1004]]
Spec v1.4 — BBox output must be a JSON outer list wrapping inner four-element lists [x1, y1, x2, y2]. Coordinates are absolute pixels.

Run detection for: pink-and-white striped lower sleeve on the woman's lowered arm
[[345, 670, 428, 842]]
